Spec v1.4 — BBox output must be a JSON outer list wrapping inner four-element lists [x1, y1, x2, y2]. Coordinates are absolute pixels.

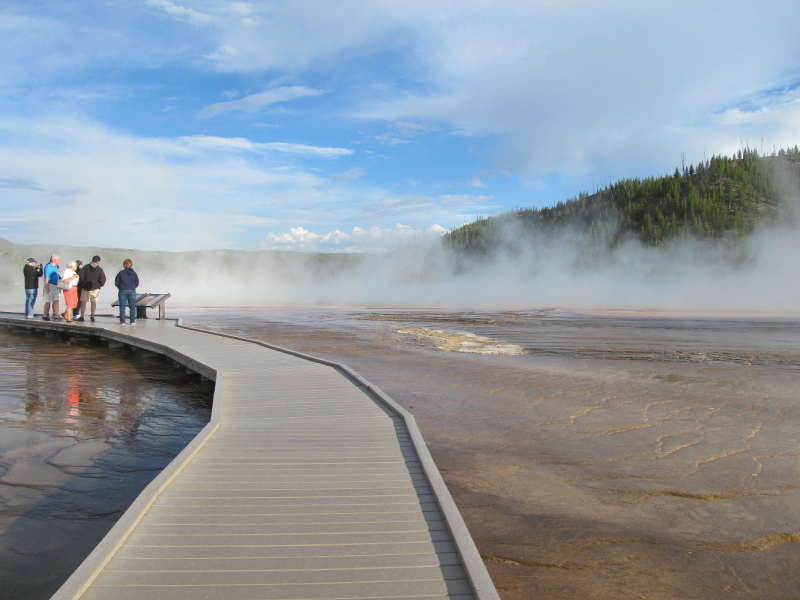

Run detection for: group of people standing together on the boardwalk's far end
[[22, 254, 139, 325]]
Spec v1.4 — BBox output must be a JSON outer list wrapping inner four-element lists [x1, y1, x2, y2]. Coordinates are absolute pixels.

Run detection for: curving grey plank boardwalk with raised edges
[[0, 314, 497, 600]]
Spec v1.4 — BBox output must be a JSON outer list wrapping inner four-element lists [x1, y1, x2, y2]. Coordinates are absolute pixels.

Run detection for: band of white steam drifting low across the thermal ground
[[0, 166, 800, 313]]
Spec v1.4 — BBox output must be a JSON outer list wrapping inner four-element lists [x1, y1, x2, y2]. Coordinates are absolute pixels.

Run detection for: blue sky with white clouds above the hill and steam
[[0, 0, 800, 252]]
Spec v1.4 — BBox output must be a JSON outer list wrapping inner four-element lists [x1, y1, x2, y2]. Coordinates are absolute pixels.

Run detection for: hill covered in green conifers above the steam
[[444, 146, 800, 252]]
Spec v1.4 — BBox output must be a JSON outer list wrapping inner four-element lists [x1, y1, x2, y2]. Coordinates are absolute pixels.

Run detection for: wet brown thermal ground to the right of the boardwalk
[[186, 310, 800, 599]]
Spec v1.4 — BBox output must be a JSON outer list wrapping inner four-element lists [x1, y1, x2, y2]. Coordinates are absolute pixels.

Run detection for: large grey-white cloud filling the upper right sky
[[114, 0, 800, 175]]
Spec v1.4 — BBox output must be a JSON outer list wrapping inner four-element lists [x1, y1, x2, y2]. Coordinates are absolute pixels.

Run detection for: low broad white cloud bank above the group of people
[[0, 118, 468, 251]]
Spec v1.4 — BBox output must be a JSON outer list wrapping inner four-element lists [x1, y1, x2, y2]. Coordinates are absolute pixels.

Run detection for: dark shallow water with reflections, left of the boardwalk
[[0, 330, 213, 600]]
